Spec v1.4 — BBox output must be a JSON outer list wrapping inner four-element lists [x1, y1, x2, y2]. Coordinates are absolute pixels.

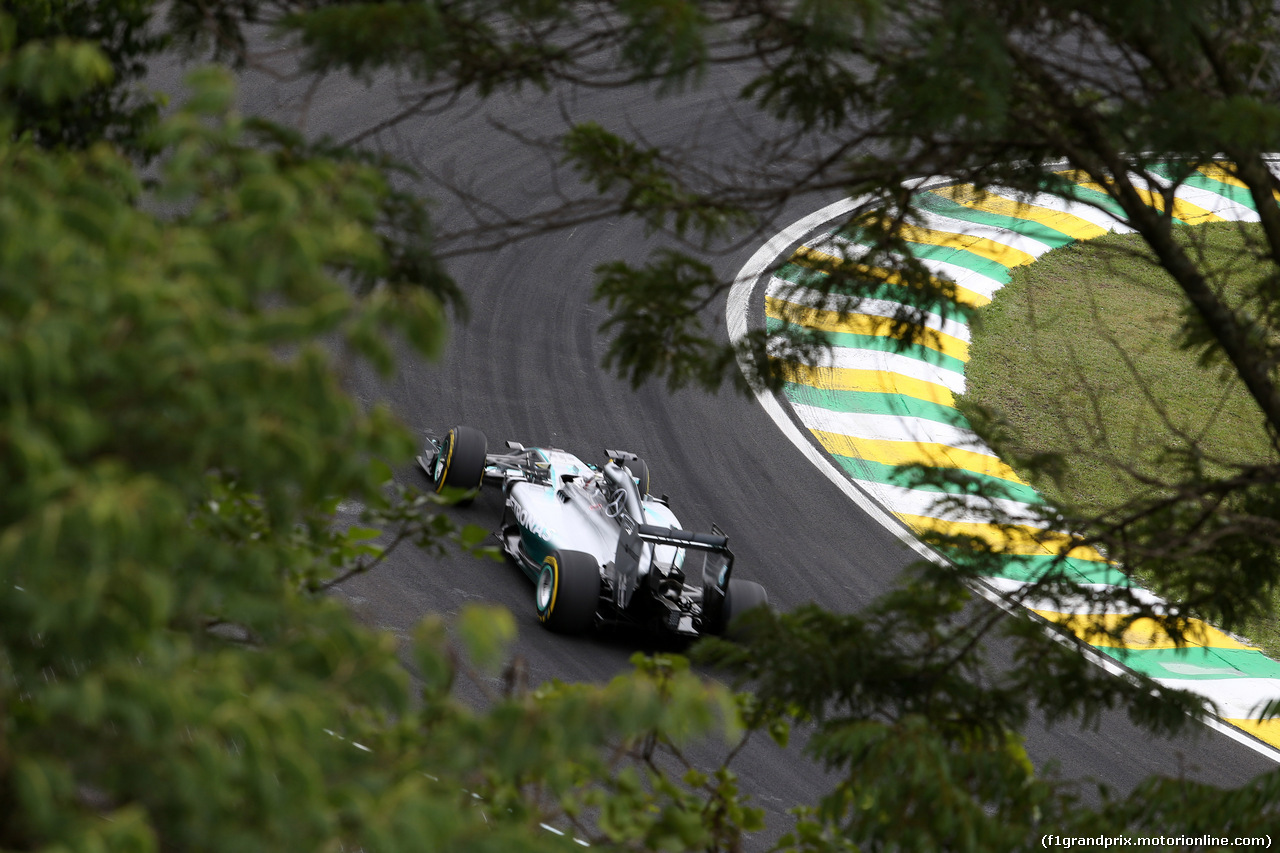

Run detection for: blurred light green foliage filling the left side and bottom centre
[[0, 23, 759, 850]]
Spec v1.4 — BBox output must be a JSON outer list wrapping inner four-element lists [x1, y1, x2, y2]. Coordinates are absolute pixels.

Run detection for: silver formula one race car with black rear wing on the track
[[417, 427, 768, 637]]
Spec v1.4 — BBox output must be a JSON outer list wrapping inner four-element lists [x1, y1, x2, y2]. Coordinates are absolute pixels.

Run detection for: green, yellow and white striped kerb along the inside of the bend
[[764, 165, 1280, 745]]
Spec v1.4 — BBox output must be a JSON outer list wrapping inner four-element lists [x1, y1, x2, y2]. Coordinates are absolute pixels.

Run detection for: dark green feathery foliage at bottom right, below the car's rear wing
[[700, 581, 1254, 852]]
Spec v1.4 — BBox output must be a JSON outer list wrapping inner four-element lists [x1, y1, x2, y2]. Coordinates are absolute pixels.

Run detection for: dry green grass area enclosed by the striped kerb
[[961, 223, 1280, 657]]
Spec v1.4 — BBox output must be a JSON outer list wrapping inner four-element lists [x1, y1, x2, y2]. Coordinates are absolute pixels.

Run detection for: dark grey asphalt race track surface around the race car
[[152, 48, 1274, 836]]
